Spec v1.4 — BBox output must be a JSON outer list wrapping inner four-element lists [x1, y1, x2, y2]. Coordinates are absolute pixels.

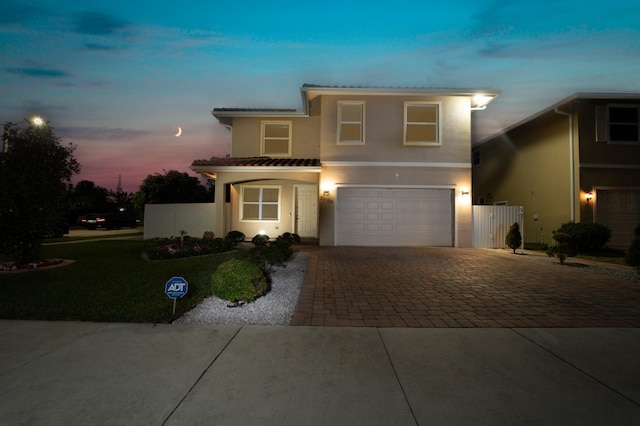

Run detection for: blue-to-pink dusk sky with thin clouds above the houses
[[0, 0, 640, 192]]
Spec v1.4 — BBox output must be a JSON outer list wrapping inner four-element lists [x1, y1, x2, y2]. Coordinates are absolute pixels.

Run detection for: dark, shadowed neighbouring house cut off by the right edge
[[473, 93, 640, 248]]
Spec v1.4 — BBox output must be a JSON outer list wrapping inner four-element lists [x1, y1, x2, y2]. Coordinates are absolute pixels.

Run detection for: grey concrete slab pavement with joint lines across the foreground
[[0, 321, 640, 426]]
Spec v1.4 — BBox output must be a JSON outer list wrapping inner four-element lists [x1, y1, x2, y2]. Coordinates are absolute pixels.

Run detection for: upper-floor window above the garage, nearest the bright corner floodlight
[[404, 102, 441, 145]]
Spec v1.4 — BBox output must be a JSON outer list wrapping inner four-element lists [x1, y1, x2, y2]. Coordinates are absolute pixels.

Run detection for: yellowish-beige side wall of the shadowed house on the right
[[473, 112, 578, 243]]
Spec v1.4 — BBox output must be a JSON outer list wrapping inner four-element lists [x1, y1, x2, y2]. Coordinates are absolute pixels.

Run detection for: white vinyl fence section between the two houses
[[473, 206, 524, 248]]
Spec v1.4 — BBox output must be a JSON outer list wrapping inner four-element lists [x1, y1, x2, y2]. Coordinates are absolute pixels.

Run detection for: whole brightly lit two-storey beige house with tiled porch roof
[[191, 84, 498, 247]]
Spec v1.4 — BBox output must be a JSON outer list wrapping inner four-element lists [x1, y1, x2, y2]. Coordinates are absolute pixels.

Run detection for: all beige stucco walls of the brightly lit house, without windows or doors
[[215, 95, 472, 247]]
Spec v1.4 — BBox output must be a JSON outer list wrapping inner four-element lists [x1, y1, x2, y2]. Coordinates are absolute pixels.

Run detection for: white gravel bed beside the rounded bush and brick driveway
[[174, 252, 310, 325]]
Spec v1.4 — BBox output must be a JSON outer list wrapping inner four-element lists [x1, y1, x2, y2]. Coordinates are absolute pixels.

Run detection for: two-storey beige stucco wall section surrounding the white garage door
[[319, 96, 472, 247]]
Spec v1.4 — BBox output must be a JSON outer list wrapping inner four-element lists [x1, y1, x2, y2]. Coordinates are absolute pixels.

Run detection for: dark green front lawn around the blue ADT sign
[[0, 240, 246, 323]]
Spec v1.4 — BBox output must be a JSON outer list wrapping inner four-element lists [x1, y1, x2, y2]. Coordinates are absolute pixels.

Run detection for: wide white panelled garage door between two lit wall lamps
[[337, 188, 453, 247]]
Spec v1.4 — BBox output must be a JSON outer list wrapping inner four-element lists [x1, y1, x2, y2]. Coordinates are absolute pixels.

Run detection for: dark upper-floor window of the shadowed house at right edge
[[596, 105, 640, 143]]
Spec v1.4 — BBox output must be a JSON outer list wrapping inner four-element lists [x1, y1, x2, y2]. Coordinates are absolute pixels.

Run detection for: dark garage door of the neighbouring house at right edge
[[595, 189, 640, 248]]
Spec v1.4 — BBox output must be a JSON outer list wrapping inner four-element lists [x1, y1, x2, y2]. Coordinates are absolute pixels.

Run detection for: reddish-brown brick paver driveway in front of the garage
[[291, 247, 640, 327]]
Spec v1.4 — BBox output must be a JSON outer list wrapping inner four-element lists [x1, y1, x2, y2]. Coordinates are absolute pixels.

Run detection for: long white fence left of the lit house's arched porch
[[144, 203, 218, 240]]
